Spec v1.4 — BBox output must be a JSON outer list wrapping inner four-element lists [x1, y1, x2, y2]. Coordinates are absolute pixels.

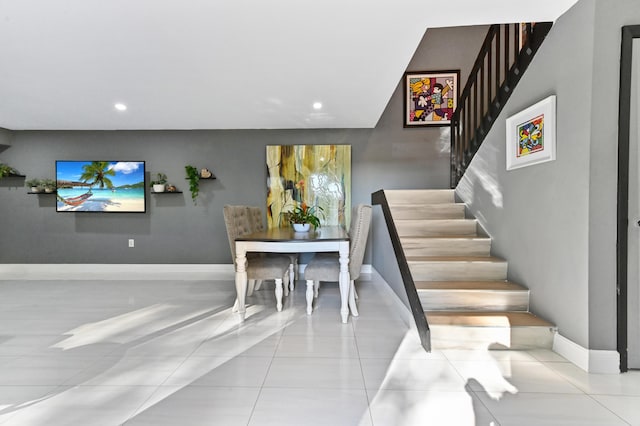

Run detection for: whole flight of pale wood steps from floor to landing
[[384, 190, 557, 349]]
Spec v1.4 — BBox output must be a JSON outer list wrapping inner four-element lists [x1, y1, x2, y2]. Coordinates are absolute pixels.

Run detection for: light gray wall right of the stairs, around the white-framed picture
[[457, 0, 640, 350]]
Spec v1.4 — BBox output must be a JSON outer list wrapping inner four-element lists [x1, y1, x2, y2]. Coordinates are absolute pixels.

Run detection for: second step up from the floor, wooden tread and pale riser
[[415, 281, 529, 312]]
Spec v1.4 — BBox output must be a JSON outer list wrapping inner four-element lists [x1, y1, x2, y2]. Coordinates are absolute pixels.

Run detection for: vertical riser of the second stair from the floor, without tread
[[418, 290, 529, 312]]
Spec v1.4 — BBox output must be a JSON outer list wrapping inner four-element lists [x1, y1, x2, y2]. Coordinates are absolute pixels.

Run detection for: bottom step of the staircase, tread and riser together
[[425, 311, 557, 350]]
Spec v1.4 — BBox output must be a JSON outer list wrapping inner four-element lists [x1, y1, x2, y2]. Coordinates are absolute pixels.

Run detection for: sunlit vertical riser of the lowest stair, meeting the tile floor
[[430, 325, 557, 350]]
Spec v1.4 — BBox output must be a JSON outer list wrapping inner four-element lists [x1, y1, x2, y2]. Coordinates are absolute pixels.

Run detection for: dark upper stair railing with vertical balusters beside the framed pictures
[[451, 22, 552, 188]]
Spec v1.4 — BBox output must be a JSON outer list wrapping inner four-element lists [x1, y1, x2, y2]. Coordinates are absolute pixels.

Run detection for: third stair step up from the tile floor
[[407, 256, 508, 281]]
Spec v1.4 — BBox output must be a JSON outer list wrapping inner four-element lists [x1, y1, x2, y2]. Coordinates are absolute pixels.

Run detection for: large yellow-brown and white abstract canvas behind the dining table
[[267, 145, 351, 228]]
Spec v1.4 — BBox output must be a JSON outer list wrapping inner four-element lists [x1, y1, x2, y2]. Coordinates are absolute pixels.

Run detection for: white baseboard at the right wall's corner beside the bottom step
[[553, 333, 620, 374]]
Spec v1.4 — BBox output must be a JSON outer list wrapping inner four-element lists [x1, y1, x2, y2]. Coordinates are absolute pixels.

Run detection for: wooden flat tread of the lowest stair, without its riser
[[425, 311, 555, 327]]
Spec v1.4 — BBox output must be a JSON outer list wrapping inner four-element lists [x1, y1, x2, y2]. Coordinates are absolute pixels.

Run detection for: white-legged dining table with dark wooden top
[[235, 226, 350, 323]]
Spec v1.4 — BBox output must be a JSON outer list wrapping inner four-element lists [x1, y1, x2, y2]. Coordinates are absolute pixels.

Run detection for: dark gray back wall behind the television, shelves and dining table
[[0, 27, 485, 264]]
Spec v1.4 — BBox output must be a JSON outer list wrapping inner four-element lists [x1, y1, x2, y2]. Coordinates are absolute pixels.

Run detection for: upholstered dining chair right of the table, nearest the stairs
[[304, 204, 372, 317]]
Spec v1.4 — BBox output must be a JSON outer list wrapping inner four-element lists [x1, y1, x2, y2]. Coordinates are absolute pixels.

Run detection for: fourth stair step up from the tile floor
[[400, 237, 491, 256]]
